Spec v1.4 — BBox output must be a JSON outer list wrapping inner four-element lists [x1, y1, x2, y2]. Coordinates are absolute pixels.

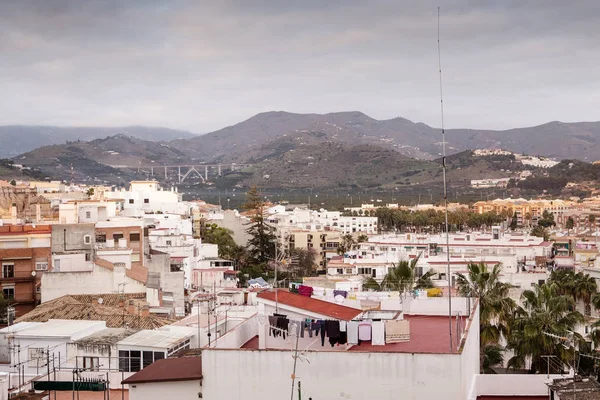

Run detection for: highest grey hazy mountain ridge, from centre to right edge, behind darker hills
[[172, 111, 600, 162]]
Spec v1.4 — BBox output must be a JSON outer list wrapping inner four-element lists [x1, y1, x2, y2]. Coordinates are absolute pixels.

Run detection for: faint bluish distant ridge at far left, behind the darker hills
[[0, 125, 195, 158]]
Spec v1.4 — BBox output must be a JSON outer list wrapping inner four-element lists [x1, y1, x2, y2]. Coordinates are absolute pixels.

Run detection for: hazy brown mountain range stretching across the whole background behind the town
[[0, 111, 600, 187]]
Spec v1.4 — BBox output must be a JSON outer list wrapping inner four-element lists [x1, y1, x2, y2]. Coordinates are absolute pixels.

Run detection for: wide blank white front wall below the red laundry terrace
[[202, 349, 468, 400]]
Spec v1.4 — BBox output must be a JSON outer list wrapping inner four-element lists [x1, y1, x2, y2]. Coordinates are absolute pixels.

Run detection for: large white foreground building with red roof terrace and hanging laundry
[[202, 292, 479, 400]]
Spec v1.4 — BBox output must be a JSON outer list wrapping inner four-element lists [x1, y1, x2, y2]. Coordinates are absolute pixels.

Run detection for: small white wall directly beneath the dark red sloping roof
[[129, 380, 200, 400]]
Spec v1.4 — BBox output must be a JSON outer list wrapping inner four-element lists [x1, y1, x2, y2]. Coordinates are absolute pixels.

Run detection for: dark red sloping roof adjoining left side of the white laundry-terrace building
[[121, 357, 202, 385]]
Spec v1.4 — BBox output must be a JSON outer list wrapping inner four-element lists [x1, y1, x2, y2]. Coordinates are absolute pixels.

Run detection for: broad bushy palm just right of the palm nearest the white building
[[507, 284, 584, 372]]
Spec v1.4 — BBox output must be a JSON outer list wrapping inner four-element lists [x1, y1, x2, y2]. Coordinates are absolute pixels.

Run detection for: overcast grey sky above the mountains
[[0, 0, 600, 133]]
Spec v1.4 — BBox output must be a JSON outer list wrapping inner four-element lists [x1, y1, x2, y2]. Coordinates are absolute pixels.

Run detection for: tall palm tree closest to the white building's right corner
[[456, 263, 517, 373]]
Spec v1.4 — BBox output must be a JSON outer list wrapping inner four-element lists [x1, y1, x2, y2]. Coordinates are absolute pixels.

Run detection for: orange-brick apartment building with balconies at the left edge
[[0, 224, 52, 318]]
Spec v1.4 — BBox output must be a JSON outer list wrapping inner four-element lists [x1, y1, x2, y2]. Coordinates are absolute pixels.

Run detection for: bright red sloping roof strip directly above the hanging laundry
[[256, 290, 362, 321]]
